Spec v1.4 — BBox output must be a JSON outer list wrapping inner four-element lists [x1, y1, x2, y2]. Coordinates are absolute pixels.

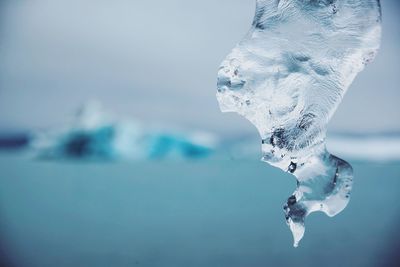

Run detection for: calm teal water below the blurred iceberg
[[0, 153, 400, 267]]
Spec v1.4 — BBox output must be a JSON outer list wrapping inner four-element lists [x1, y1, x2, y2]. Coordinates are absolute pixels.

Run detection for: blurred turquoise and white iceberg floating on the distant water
[[31, 101, 216, 160]]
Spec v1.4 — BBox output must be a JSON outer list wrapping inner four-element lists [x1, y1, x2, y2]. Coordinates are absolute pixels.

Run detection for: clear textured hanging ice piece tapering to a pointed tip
[[217, 0, 381, 247]]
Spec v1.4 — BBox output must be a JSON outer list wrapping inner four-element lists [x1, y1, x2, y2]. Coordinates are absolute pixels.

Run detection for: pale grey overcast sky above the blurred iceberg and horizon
[[0, 0, 400, 135]]
